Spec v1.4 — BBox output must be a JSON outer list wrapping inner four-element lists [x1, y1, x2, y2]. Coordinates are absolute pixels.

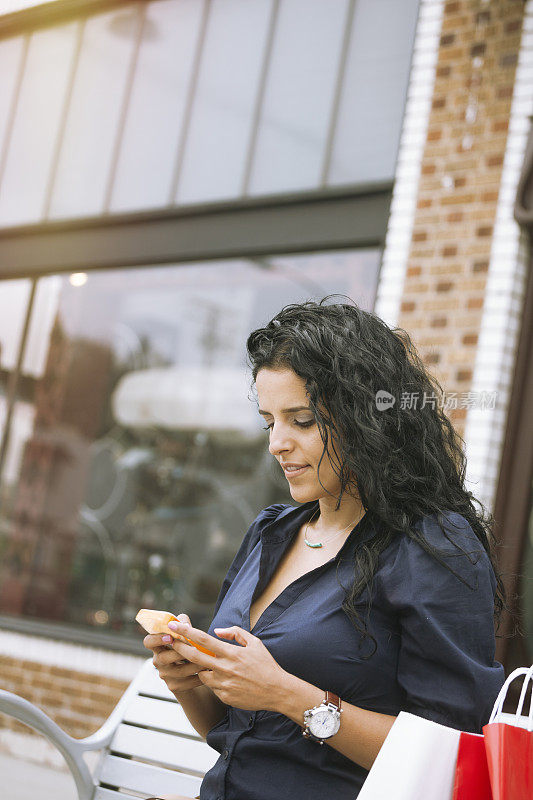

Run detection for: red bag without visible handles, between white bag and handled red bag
[[452, 731, 492, 800]]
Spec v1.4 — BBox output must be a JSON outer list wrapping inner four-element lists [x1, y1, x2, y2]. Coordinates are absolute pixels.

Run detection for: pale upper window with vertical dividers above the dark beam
[[0, 0, 419, 226]]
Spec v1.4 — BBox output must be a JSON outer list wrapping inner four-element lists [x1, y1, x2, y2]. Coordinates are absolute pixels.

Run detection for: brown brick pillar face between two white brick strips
[[397, 0, 524, 435]]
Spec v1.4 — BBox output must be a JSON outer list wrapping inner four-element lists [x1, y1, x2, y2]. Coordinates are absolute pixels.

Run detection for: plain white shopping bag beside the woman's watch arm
[[357, 711, 461, 800]]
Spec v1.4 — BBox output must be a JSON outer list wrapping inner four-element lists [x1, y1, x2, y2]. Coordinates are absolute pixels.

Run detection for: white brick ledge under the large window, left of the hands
[[0, 631, 144, 683]]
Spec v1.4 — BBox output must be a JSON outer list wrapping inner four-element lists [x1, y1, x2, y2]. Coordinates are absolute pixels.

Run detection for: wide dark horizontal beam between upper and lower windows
[[0, 181, 392, 278]]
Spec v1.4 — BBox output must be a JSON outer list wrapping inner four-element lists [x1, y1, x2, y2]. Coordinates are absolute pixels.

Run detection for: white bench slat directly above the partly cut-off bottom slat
[[100, 756, 202, 797]]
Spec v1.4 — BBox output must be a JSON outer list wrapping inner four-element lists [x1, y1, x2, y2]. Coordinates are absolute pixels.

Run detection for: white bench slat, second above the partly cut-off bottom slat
[[109, 725, 219, 775]]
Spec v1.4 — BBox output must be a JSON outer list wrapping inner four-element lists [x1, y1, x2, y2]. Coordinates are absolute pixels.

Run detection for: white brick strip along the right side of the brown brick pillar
[[464, 0, 533, 511]]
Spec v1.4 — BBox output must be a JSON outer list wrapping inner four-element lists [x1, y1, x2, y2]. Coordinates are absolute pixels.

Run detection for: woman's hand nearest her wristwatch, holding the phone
[[166, 622, 289, 711]]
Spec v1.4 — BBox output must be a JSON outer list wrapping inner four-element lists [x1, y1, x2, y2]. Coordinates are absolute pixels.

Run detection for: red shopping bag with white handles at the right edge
[[483, 665, 533, 800]]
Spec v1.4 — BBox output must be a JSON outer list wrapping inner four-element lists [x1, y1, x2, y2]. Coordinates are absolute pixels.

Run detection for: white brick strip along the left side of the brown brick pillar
[[374, 0, 444, 327]]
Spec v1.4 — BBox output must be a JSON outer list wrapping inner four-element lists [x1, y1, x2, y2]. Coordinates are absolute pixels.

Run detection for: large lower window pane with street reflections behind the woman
[[0, 250, 380, 640]]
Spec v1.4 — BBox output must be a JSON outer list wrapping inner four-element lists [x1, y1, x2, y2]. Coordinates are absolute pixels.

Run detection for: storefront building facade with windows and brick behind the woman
[[0, 0, 533, 776]]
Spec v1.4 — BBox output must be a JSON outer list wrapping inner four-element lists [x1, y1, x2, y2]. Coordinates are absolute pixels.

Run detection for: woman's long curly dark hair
[[246, 295, 513, 655]]
